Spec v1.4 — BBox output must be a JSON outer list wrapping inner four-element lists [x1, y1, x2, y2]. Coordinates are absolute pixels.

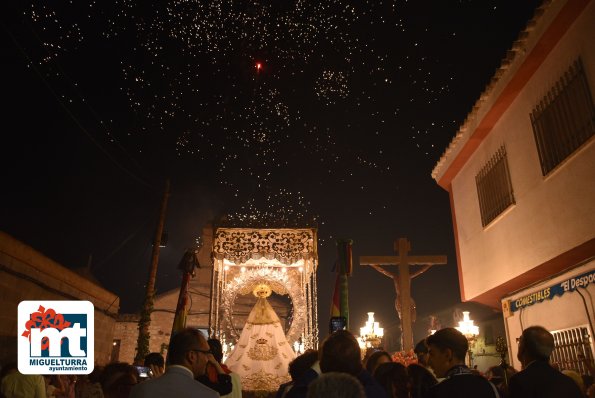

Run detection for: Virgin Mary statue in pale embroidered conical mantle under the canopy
[[225, 283, 295, 391]]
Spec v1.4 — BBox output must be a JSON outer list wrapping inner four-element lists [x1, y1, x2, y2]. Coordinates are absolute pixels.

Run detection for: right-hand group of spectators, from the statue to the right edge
[[276, 326, 595, 398]]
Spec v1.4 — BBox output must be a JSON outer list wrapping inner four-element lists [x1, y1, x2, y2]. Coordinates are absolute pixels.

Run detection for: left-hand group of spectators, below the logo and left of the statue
[[0, 328, 242, 398]]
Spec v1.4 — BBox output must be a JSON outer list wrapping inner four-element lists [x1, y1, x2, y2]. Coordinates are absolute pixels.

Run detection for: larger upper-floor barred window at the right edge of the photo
[[531, 58, 595, 176]]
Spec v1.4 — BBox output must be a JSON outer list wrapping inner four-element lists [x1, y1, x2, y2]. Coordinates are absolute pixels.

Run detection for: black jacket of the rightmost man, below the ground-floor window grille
[[508, 361, 583, 398]]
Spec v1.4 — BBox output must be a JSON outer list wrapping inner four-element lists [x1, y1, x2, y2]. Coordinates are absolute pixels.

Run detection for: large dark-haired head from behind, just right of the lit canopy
[[320, 330, 362, 376]]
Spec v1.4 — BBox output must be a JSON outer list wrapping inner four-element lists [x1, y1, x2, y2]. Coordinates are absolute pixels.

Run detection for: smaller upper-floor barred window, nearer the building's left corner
[[475, 146, 515, 227]]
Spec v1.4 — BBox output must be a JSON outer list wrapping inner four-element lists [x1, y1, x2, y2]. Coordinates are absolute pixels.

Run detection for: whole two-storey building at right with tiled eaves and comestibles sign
[[432, 0, 595, 370]]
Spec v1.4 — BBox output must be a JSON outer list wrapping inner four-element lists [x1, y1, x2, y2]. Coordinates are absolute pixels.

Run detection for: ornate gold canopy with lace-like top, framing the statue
[[210, 228, 318, 348]]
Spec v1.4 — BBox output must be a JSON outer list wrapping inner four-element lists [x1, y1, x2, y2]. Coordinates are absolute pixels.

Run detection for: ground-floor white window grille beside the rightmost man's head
[[550, 326, 593, 374]]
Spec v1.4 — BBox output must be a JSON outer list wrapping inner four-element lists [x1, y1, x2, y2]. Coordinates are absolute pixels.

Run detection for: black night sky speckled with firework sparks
[[0, 0, 539, 338]]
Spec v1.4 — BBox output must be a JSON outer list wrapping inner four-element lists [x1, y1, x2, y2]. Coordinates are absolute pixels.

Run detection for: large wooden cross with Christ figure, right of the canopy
[[359, 238, 446, 352]]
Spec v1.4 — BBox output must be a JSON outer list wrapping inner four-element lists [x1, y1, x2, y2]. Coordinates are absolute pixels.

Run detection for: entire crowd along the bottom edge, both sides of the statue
[[0, 326, 595, 398]]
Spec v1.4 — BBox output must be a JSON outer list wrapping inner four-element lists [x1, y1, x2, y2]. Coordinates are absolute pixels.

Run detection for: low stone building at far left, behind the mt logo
[[0, 231, 120, 365]]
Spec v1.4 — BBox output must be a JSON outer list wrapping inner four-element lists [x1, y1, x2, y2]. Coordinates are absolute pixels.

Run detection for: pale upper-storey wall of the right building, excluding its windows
[[452, 2, 595, 300]]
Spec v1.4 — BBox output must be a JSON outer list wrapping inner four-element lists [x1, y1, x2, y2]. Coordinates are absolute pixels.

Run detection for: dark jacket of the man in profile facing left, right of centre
[[427, 365, 499, 398]]
